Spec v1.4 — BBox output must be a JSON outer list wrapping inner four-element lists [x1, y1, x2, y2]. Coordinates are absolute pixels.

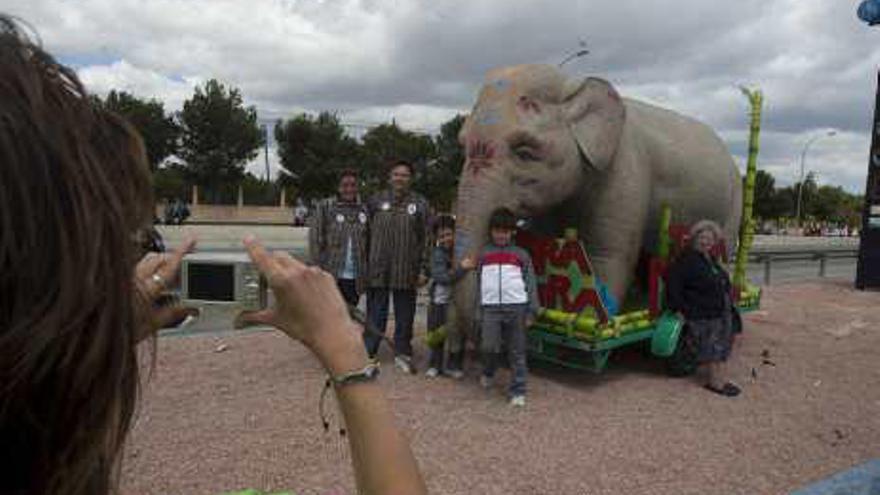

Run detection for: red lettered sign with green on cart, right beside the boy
[[516, 230, 617, 322]]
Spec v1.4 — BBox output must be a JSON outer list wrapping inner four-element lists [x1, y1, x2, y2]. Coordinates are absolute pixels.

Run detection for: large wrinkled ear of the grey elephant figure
[[562, 77, 626, 170]]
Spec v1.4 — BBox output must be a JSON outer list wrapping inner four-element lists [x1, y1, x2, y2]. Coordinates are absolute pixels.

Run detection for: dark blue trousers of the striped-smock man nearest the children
[[364, 287, 416, 356]]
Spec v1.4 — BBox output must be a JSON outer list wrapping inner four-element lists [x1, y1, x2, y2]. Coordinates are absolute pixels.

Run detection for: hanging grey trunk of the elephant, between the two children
[[453, 162, 513, 340]]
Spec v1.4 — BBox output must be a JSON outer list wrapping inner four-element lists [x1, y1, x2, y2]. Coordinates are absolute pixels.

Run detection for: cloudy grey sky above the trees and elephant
[[6, 0, 880, 192]]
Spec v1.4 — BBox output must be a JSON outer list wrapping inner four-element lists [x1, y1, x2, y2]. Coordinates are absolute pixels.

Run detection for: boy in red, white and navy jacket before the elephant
[[462, 208, 538, 407]]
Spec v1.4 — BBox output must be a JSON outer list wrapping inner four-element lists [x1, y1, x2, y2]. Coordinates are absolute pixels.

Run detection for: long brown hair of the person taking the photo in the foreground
[[0, 16, 152, 494]]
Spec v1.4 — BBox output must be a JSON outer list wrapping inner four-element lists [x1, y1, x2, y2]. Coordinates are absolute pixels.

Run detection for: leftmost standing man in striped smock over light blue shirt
[[309, 170, 368, 306]]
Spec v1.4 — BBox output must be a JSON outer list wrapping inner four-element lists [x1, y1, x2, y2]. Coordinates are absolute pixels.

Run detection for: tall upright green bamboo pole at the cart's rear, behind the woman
[[733, 87, 764, 292]]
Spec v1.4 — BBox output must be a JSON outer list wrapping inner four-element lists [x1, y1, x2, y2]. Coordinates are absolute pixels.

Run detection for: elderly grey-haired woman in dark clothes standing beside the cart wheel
[[666, 220, 740, 397]]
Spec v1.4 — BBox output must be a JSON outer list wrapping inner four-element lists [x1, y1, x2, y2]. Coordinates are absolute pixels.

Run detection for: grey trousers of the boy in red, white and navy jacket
[[480, 305, 528, 396]]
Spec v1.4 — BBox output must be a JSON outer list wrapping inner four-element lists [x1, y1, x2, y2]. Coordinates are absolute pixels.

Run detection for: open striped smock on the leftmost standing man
[[309, 197, 369, 292]]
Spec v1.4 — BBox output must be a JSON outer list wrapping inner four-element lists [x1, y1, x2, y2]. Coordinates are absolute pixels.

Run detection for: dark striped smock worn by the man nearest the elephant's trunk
[[367, 191, 430, 289]]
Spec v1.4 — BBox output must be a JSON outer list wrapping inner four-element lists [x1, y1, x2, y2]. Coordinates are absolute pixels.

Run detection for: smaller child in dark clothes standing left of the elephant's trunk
[[425, 215, 466, 378]]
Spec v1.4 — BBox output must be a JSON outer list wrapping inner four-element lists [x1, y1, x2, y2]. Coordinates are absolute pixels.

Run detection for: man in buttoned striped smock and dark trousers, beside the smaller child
[[364, 160, 429, 373]]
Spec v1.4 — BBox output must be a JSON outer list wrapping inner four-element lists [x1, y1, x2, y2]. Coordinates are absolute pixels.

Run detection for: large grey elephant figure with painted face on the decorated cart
[[454, 65, 742, 325]]
